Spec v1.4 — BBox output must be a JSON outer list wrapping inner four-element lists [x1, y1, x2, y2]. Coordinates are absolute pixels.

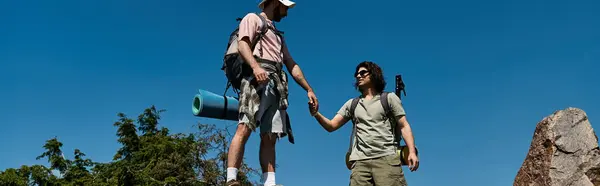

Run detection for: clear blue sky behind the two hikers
[[0, 0, 600, 186]]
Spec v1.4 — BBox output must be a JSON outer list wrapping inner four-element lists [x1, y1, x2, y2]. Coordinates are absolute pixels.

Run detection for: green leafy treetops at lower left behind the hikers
[[0, 106, 259, 186]]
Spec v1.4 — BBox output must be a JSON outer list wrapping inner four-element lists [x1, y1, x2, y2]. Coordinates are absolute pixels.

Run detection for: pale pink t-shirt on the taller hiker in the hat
[[238, 13, 291, 62]]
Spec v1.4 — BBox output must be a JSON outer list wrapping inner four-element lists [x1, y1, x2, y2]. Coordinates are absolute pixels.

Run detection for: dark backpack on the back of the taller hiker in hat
[[221, 13, 269, 93]]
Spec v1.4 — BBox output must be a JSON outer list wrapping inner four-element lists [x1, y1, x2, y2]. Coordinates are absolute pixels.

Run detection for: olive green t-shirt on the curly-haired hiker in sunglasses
[[337, 93, 406, 161]]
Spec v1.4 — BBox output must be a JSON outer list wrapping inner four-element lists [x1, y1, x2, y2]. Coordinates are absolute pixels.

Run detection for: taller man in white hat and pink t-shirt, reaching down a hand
[[227, 0, 318, 186]]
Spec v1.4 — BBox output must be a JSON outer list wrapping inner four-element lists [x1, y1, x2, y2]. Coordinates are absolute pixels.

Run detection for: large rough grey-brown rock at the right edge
[[513, 108, 600, 186]]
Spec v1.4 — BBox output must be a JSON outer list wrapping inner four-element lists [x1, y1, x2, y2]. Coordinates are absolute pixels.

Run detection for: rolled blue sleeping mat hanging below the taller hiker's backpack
[[192, 89, 239, 121]]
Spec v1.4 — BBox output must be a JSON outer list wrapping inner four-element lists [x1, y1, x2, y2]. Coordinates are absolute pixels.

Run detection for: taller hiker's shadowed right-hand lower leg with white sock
[[259, 133, 277, 186]]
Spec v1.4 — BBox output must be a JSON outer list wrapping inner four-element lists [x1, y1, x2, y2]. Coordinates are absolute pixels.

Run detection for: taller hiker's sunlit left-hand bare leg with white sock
[[227, 123, 252, 181]]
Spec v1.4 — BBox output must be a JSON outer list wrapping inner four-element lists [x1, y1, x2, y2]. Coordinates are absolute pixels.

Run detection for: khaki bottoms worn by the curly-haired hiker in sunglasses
[[350, 153, 407, 186]]
